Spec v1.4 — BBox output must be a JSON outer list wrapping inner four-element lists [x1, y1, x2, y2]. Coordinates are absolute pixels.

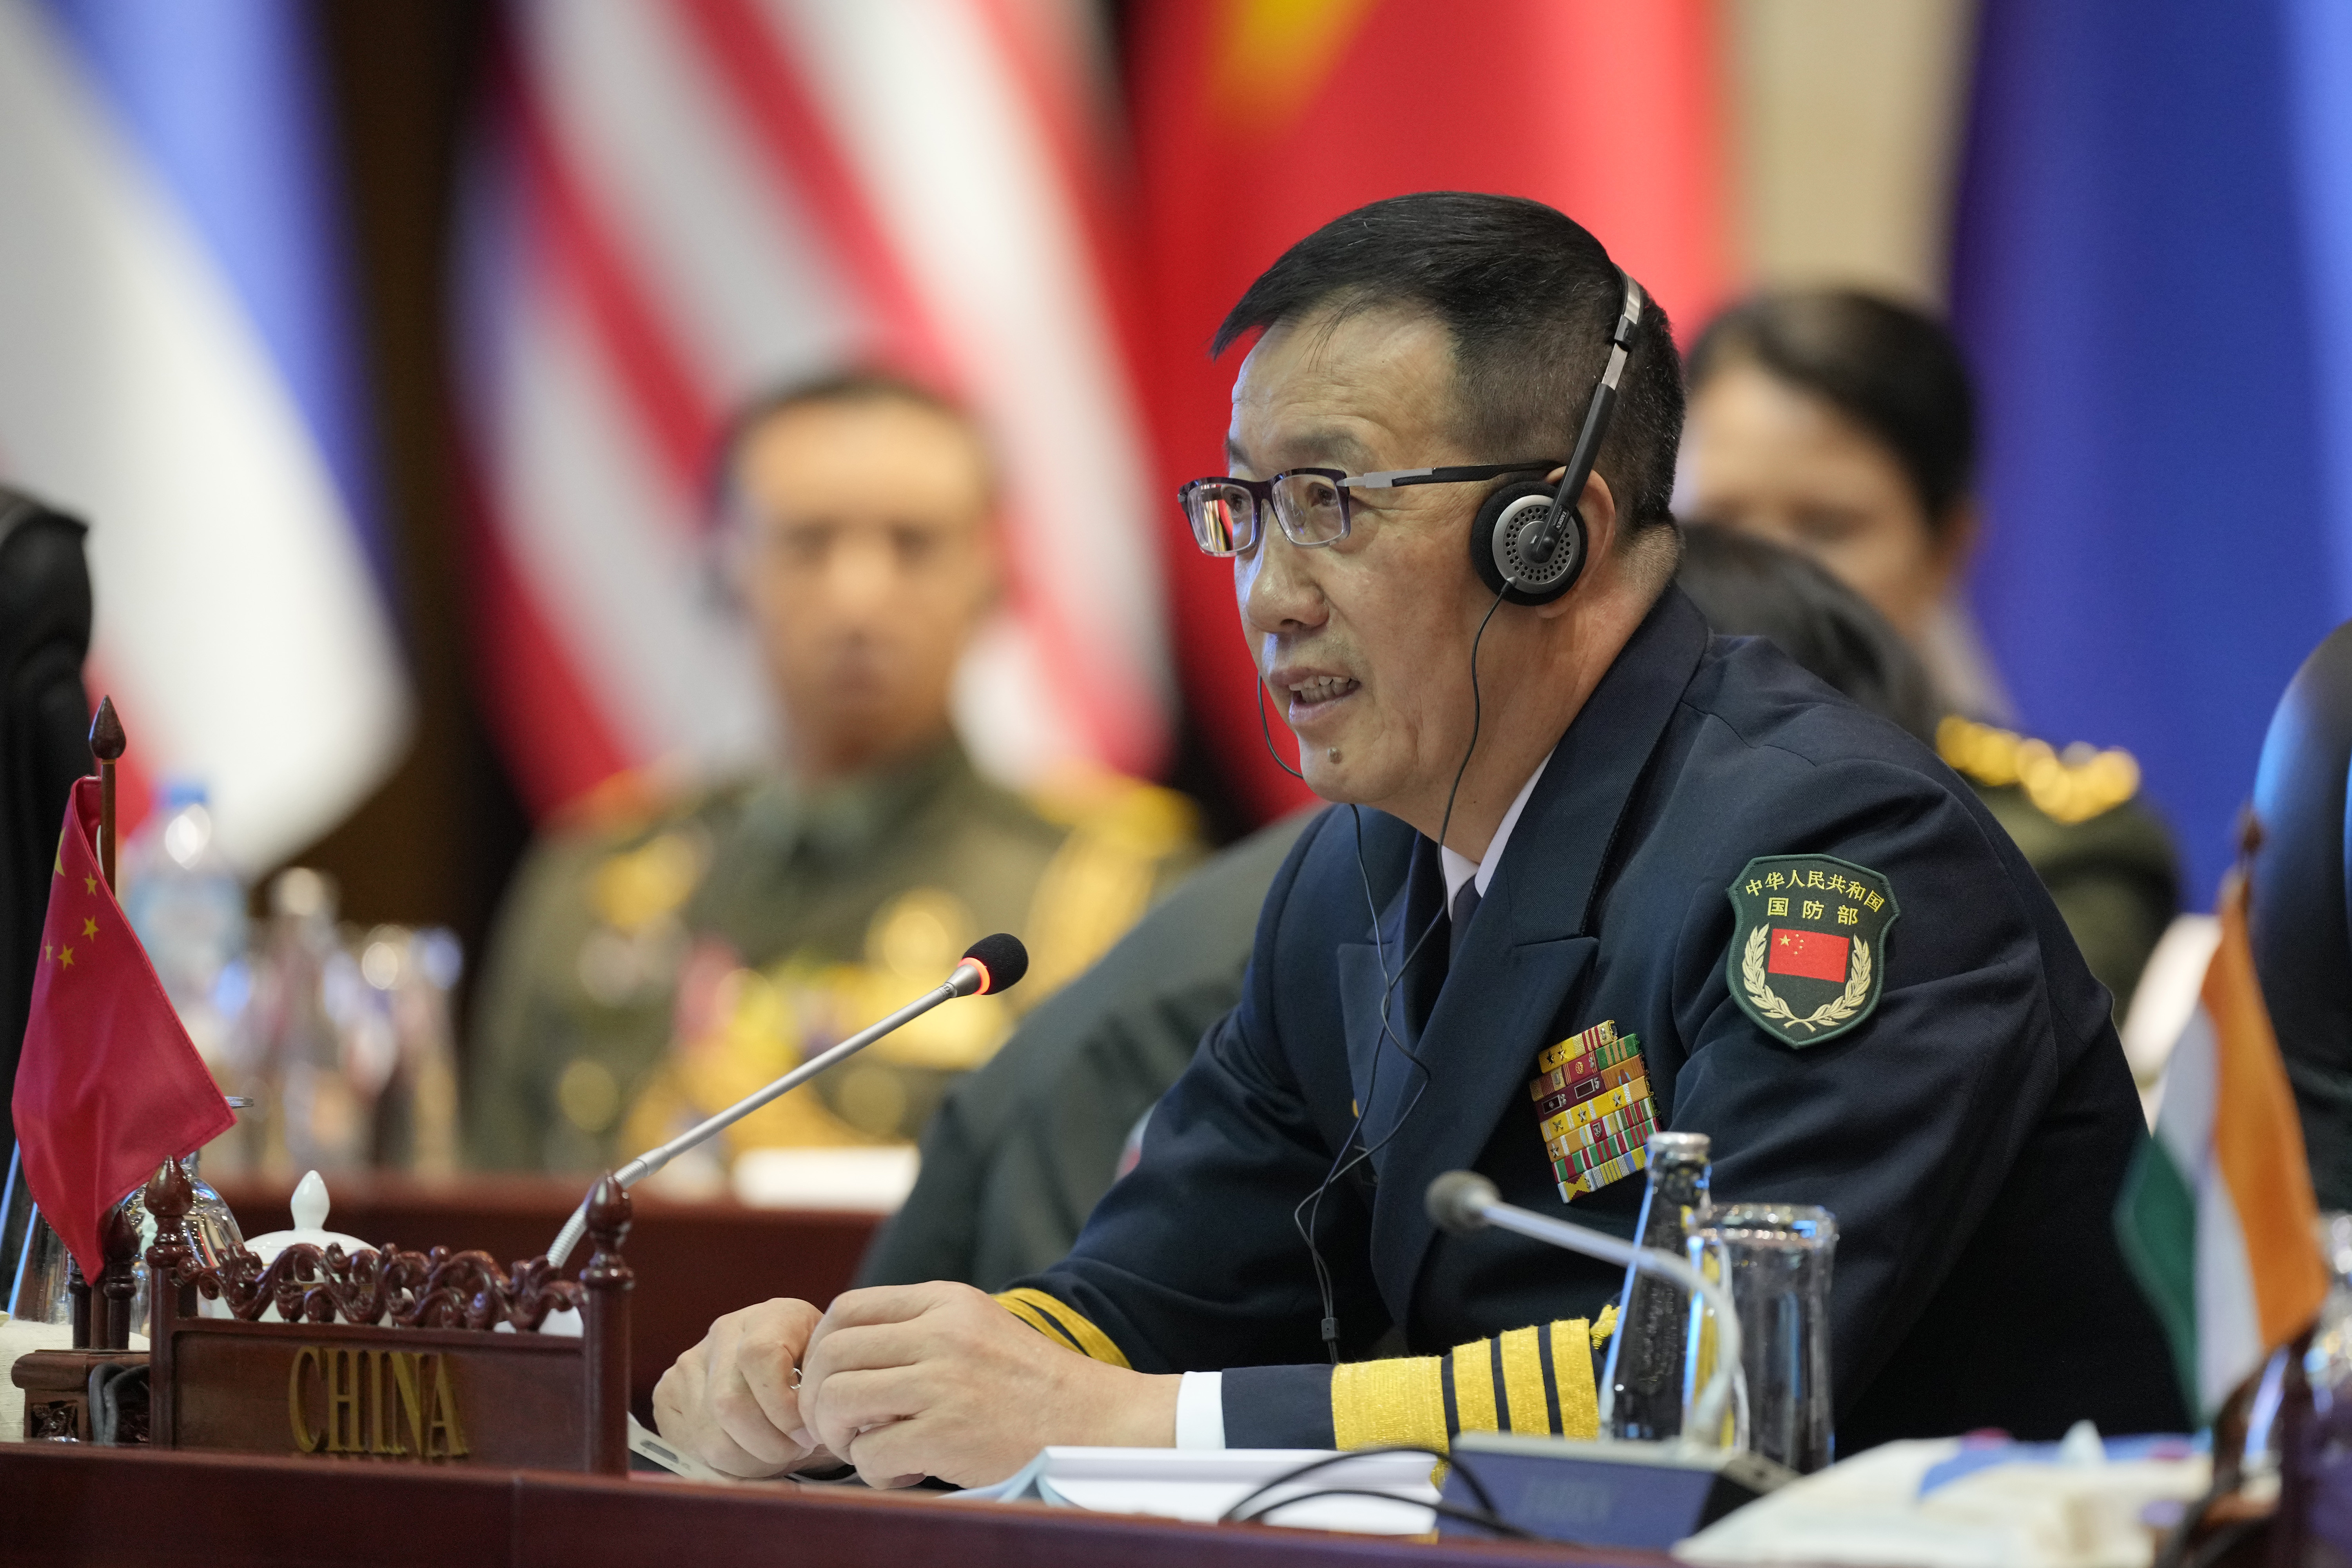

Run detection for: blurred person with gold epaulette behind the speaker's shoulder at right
[[1677, 289, 2180, 1018]]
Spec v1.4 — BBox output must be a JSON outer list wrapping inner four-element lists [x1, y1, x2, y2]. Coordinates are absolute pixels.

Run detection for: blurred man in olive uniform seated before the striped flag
[[468, 376, 1192, 1173]]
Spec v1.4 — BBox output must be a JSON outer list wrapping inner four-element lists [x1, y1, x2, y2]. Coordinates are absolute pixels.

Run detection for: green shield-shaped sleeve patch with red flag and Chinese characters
[[1724, 856, 1903, 1046]]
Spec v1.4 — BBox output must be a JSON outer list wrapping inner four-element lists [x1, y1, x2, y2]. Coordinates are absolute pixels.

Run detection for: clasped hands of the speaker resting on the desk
[[654, 1283, 1181, 1486]]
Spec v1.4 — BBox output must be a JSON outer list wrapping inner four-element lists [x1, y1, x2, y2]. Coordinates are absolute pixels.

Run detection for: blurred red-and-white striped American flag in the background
[[456, 0, 1176, 809]]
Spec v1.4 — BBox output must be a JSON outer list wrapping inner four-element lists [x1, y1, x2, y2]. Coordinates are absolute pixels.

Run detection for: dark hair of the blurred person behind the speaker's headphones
[[1691, 289, 1976, 534]]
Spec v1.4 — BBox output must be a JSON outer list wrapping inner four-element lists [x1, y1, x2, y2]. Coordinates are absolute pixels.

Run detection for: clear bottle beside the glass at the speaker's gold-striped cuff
[[1599, 1133, 1708, 1441]]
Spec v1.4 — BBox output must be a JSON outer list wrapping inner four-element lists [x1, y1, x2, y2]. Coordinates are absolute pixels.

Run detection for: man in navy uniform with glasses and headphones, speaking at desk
[[654, 193, 2183, 1483]]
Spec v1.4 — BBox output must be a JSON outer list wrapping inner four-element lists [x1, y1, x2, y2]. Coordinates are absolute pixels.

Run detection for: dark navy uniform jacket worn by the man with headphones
[[1028, 588, 2185, 1453]]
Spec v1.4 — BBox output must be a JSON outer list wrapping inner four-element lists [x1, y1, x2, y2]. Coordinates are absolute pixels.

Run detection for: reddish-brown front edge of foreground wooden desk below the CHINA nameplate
[[0, 1448, 1618, 1568]]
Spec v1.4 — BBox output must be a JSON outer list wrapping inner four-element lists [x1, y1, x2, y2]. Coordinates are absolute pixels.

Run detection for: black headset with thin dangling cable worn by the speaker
[[1249, 268, 1649, 1366]]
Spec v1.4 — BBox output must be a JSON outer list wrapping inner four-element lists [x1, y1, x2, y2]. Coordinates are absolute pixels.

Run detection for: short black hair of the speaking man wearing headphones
[[1211, 191, 1682, 536]]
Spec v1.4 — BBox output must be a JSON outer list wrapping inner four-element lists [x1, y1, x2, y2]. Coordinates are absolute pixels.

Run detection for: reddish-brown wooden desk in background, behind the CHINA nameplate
[[202, 1173, 877, 1425]]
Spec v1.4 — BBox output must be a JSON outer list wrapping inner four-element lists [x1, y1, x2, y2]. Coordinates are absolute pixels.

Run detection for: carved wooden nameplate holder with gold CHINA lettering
[[16, 1161, 633, 1474]]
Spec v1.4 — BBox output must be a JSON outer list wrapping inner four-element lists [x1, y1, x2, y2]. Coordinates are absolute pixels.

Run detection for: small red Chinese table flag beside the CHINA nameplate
[[12, 778, 235, 1279]]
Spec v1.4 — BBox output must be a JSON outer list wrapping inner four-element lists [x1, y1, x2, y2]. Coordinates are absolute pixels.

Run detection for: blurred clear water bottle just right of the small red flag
[[122, 778, 252, 1089]]
